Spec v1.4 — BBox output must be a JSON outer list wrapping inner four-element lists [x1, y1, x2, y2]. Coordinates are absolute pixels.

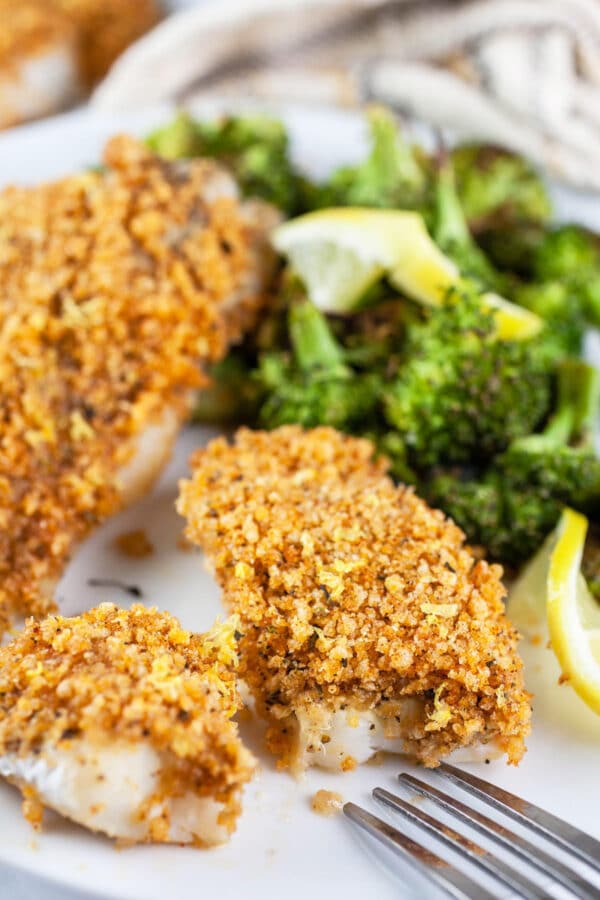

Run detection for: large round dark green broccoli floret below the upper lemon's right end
[[385, 290, 553, 468]]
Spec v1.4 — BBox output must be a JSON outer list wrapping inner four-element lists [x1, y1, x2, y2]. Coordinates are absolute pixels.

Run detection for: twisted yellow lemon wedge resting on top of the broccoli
[[272, 207, 543, 340]]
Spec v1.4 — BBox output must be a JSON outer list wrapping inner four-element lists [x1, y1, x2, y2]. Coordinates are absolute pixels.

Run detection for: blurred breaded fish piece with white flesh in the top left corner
[[0, 0, 83, 128]]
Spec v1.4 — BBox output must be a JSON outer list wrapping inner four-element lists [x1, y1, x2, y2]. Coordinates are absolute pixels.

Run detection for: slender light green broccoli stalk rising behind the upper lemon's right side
[[433, 155, 505, 293]]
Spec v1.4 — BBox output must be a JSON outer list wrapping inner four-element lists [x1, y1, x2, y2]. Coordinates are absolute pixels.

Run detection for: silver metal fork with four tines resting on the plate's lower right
[[344, 764, 600, 900]]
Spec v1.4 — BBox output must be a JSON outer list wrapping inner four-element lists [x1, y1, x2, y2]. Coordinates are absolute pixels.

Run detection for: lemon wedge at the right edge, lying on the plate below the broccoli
[[507, 509, 600, 714]]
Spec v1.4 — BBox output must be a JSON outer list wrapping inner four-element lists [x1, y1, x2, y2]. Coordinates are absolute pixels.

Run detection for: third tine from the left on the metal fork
[[398, 773, 600, 900]]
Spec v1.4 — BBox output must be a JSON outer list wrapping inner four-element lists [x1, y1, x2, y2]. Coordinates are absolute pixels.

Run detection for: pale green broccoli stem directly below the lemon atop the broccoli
[[289, 300, 348, 375]]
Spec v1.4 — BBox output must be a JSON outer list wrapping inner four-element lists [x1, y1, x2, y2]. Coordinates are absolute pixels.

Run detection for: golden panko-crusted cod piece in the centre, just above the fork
[[178, 426, 531, 771]]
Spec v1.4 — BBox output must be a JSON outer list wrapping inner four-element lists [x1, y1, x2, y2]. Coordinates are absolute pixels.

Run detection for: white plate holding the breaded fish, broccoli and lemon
[[0, 100, 600, 900]]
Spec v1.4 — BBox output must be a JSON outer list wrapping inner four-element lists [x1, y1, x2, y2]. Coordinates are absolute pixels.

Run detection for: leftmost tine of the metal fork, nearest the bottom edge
[[344, 803, 496, 900]]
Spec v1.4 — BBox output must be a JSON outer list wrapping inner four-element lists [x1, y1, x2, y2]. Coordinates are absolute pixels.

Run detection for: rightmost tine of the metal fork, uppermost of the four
[[439, 763, 600, 872]]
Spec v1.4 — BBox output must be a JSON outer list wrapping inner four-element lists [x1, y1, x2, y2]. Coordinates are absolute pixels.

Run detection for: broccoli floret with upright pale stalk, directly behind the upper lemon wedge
[[310, 107, 429, 209]]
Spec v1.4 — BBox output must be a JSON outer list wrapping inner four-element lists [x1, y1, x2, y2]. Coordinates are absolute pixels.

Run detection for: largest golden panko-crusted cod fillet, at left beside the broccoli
[[0, 137, 278, 627]]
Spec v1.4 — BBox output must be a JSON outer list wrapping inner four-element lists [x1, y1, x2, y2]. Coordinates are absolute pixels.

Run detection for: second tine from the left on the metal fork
[[373, 788, 548, 900]]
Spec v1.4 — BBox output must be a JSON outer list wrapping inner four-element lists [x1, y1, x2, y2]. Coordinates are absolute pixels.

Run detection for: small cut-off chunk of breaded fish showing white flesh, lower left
[[0, 603, 255, 846]]
